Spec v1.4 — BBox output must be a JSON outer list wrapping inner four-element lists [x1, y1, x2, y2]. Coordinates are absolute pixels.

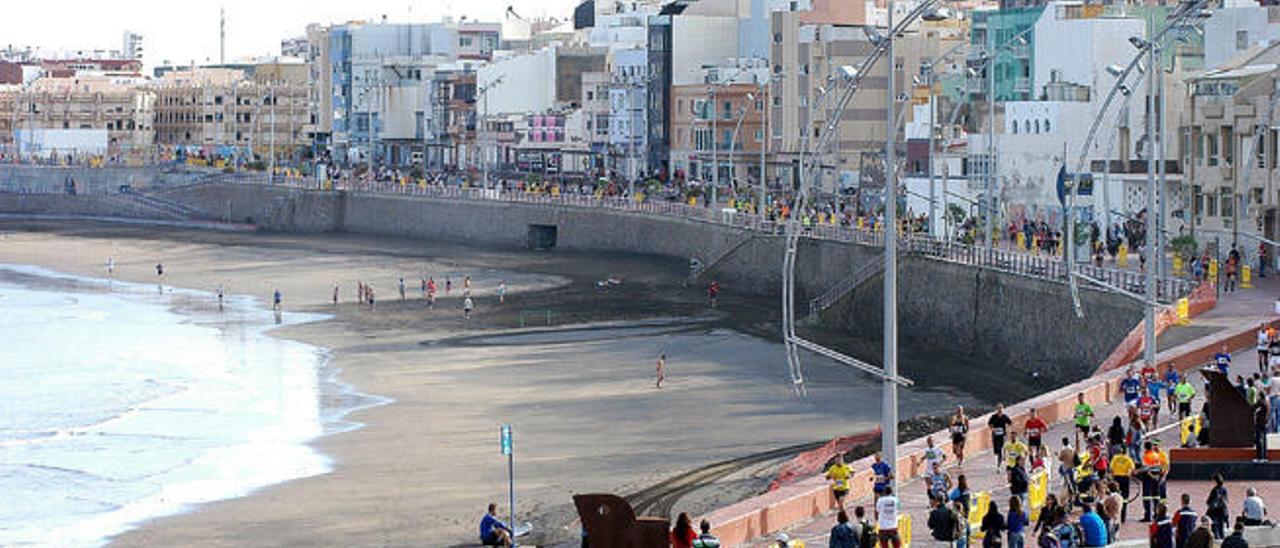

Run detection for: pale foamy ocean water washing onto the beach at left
[[0, 265, 380, 547]]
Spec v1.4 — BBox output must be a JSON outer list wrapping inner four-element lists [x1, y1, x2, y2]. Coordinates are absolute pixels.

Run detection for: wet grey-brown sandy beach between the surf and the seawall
[[0, 223, 978, 545]]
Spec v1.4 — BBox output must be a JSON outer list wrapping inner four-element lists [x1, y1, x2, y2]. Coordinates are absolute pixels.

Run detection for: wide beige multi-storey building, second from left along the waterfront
[[152, 63, 314, 159]]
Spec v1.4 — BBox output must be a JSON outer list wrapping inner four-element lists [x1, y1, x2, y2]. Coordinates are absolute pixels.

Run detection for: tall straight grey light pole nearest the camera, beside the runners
[[880, 0, 897, 487]]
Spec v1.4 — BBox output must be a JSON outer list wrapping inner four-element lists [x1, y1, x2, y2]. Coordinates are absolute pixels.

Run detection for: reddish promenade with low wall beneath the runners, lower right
[[703, 277, 1280, 547]]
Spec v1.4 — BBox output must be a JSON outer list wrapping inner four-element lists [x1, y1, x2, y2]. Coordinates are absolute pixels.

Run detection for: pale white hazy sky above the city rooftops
[[0, 0, 577, 67]]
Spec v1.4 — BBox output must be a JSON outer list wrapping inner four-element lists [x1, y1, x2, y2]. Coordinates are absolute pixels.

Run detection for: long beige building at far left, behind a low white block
[[0, 77, 154, 159]]
